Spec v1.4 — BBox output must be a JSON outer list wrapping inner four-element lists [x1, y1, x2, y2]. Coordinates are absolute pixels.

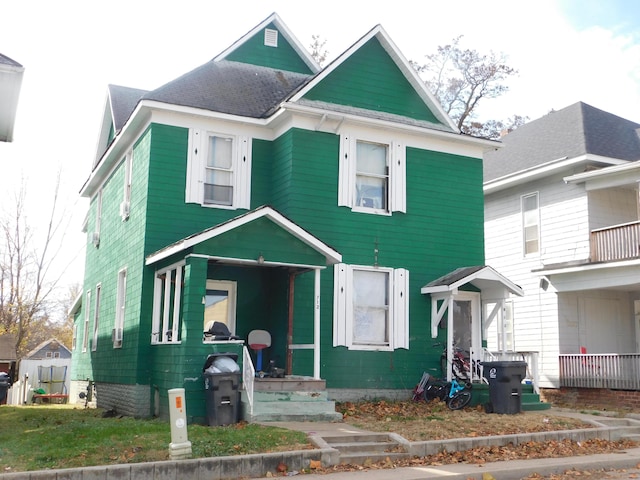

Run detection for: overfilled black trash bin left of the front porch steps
[[202, 352, 241, 426]]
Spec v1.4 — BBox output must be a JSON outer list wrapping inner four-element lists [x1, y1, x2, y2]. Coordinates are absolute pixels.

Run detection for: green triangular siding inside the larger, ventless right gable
[[304, 38, 441, 123]]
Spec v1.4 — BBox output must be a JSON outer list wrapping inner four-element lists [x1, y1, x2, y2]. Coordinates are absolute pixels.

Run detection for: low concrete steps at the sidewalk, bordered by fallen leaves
[[323, 433, 409, 465]]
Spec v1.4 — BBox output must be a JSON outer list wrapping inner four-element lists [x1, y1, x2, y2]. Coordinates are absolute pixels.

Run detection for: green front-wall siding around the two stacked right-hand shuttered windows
[[284, 130, 484, 388]]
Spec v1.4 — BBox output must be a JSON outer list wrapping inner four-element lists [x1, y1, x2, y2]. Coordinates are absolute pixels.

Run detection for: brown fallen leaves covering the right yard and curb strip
[[314, 401, 640, 480]]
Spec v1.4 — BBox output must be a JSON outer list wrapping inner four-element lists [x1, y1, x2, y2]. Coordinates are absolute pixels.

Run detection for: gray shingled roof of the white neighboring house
[[484, 102, 640, 182]]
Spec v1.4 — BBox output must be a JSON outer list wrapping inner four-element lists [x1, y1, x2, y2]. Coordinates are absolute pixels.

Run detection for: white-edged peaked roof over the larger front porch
[[145, 206, 342, 267]]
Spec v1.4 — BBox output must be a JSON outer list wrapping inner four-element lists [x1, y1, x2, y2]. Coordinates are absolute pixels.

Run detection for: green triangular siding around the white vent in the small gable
[[226, 24, 313, 74]]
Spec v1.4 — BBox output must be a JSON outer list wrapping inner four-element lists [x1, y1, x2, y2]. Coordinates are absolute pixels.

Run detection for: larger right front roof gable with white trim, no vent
[[292, 26, 458, 132]]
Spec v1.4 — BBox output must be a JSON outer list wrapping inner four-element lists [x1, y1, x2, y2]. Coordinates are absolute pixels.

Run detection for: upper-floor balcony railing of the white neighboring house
[[591, 222, 640, 262]]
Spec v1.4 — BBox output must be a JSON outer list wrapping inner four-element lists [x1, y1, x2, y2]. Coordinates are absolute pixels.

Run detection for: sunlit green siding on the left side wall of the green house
[[72, 131, 151, 384]]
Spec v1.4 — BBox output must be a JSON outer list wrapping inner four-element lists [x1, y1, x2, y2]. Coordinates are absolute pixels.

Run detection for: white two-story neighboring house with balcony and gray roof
[[484, 102, 640, 390]]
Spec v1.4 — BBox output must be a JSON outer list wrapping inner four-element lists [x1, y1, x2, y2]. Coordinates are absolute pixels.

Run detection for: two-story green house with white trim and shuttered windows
[[72, 14, 518, 422]]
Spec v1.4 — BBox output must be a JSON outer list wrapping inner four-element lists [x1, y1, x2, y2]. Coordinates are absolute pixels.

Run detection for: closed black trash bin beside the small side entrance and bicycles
[[483, 361, 527, 414]]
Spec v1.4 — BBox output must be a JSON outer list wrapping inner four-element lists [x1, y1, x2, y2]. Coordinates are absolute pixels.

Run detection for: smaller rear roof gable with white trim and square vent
[[213, 13, 319, 75]]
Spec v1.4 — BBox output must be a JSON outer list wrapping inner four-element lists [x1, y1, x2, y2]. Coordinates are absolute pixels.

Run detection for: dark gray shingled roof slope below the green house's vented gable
[[143, 60, 311, 118]]
